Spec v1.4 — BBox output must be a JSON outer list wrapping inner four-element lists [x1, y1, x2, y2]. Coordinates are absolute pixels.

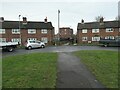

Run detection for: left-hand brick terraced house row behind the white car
[[0, 17, 54, 45]]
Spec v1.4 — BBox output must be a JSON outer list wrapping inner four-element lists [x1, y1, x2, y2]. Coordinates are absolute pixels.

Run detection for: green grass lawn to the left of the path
[[2, 53, 57, 88]]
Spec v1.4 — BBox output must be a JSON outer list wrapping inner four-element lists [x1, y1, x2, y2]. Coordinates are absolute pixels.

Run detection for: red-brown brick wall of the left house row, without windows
[[0, 29, 54, 45]]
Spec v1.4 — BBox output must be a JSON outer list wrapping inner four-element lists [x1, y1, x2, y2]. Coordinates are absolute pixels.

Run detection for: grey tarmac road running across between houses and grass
[[0, 46, 118, 57]]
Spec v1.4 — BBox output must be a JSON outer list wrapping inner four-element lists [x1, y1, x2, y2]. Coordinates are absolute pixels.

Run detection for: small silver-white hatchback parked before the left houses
[[25, 40, 45, 50]]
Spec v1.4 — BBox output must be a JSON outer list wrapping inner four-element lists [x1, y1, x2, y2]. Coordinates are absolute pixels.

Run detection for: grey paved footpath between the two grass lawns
[[56, 52, 104, 88]]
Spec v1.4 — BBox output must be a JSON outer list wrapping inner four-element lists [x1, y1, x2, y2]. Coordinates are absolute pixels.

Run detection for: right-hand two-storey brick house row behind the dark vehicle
[[77, 19, 120, 44]]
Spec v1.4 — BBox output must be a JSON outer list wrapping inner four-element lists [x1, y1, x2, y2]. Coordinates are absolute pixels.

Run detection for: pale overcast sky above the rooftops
[[0, 0, 119, 33]]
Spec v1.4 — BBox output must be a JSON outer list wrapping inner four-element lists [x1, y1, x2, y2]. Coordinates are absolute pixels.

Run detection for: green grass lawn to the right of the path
[[74, 50, 118, 88]]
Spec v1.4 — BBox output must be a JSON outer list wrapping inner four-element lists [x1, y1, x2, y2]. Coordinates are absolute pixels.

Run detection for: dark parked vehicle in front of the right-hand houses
[[99, 37, 120, 47]]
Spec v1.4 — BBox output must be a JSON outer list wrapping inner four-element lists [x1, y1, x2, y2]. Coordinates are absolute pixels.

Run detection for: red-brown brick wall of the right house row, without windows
[[77, 28, 119, 44]]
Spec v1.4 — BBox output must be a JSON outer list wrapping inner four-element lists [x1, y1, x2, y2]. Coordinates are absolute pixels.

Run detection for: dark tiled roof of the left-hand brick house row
[[0, 21, 54, 29]]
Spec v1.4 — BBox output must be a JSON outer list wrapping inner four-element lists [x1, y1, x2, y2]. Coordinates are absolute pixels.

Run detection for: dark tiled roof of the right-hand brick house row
[[77, 21, 118, 30]]
